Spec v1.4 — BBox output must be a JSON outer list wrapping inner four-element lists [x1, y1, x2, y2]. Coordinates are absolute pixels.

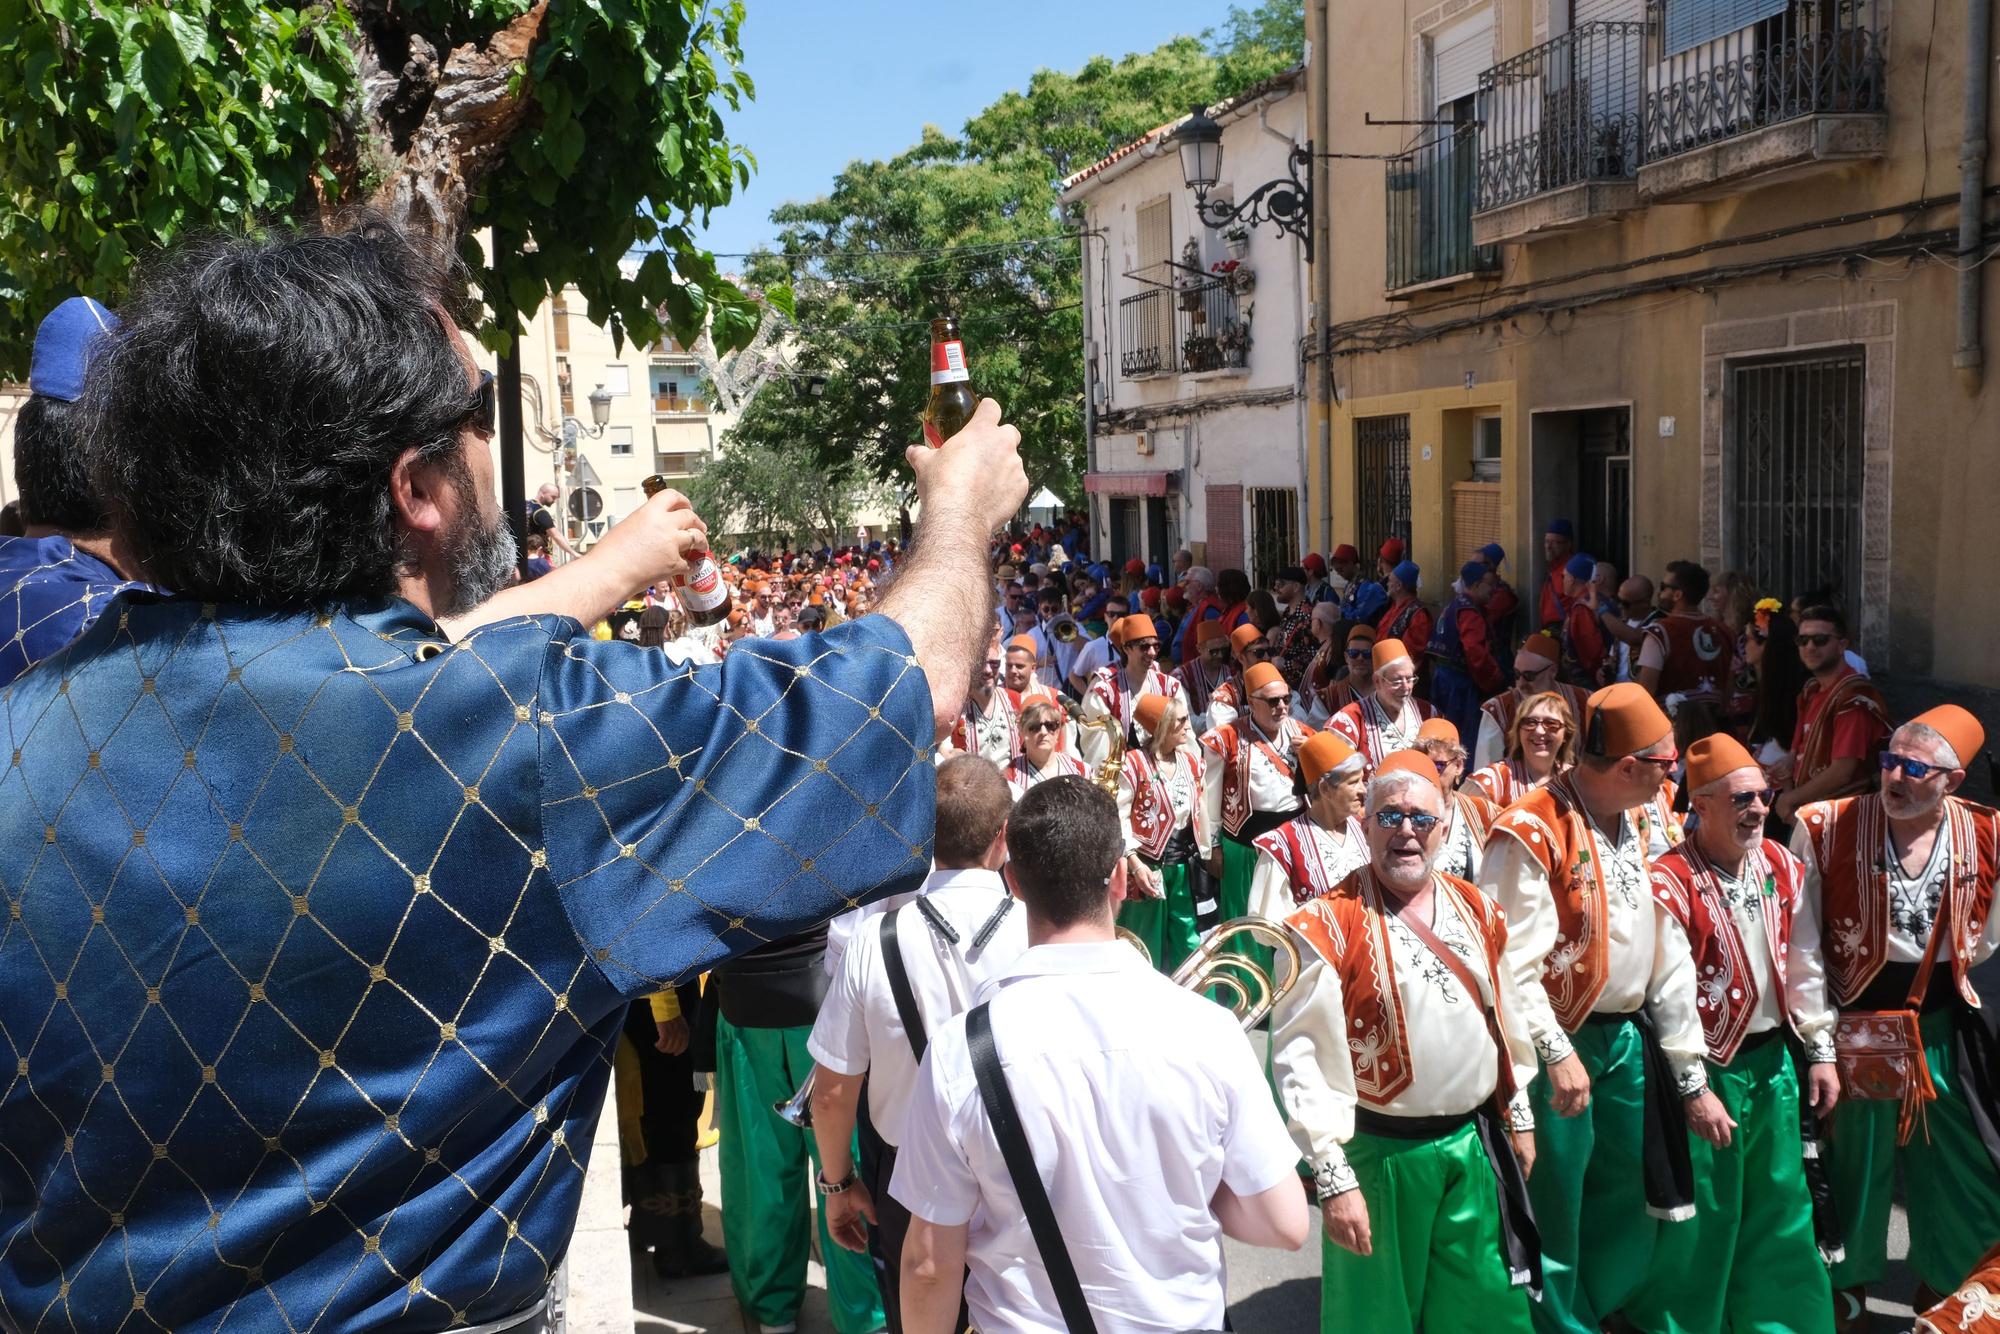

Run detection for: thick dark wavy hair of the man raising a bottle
[[84, 216, 482, 606]]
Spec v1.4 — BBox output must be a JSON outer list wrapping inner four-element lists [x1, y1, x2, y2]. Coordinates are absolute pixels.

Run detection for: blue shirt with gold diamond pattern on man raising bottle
[[0, 592, 936, 1332]]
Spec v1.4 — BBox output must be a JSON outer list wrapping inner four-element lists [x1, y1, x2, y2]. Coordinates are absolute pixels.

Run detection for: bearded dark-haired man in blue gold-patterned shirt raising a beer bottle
[[0, 224, 1026, 1334]]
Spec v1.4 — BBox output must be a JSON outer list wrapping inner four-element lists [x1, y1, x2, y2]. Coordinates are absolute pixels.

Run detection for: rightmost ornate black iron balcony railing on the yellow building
[[1642, 0, 1884, 162]]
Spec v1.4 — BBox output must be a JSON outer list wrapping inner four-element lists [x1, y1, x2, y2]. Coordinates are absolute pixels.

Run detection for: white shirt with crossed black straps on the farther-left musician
[[806, 870, 1028, 1144]]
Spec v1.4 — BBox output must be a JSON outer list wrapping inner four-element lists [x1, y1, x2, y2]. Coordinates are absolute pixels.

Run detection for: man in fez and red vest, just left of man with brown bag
[[1626, 732, 1840, 1330]]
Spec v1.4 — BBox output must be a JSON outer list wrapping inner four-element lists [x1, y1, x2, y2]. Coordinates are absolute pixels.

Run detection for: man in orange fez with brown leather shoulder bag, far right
[[1792, 708, 2000, 1330]]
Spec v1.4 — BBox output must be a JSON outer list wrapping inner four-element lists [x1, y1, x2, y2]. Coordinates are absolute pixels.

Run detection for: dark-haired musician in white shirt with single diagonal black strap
[[890, 778, 1310, 1334]]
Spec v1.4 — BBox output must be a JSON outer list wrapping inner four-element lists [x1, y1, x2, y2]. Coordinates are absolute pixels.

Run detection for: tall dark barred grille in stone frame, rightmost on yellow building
[[1728, 350, 1866, 612]]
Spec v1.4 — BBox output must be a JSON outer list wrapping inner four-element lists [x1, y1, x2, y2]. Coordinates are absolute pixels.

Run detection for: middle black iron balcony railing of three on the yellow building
[[1476, 22, 1648, 212]]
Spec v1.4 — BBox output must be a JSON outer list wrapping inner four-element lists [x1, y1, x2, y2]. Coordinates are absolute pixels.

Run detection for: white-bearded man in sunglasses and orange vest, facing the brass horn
[[1272, 752, 1538, 1334]]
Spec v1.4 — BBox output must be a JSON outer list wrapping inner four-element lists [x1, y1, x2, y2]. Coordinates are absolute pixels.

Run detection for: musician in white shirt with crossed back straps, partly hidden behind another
[[806, 756, 1028, 1330]]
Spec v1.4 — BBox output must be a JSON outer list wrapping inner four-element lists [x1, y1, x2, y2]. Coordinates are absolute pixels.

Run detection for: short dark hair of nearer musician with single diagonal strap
[[1006, 774, 1124, 928]]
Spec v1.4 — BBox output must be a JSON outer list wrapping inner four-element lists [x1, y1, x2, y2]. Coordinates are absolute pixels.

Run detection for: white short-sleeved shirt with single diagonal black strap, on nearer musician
[[890, 940, 1298, 1334]]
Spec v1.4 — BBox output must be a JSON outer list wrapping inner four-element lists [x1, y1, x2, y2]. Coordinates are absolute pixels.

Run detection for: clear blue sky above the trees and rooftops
[[702, 0, 1244, 252]]
